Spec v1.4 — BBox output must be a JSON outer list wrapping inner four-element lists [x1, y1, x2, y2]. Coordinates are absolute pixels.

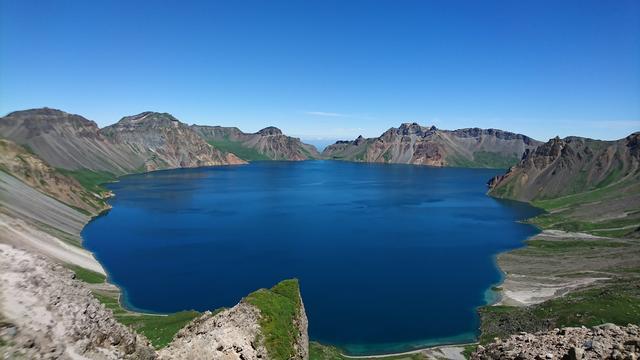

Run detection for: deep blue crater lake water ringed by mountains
[[83, 161, 538, 353]]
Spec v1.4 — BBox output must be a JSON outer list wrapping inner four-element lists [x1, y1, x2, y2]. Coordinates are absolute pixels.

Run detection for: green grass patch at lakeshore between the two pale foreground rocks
[[93, 292, 200, 349]]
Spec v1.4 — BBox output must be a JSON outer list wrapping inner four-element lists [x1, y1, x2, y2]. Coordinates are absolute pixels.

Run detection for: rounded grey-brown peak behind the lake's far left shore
[[100, 112, 244, 171]]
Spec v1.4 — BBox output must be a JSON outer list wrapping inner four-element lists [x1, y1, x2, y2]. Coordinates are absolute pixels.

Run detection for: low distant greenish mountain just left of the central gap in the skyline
[[191, 125, 321, 161]]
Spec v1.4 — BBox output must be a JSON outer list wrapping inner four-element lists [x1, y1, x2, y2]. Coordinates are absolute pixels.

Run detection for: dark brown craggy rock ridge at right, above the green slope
[[489, 133, 640, 201]]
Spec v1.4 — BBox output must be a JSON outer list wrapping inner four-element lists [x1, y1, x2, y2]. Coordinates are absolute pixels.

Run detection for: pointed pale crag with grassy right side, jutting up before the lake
[[159, 280, 309, 360]]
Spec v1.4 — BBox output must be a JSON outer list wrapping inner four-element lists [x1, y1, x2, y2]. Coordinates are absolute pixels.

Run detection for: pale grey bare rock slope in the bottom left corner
[[0, 244, 156, 359]]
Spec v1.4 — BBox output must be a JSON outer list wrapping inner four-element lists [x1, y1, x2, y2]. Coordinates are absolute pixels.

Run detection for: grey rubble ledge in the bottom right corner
[[471, 324, 640, 360]]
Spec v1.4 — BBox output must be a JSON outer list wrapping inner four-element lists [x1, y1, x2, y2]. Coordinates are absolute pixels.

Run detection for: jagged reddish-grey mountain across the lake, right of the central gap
[[322, 123, 540, 168]]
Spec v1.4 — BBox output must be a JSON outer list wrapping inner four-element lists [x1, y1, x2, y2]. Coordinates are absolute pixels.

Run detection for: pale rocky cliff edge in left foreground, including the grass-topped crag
[[0, 244, 308, 360]]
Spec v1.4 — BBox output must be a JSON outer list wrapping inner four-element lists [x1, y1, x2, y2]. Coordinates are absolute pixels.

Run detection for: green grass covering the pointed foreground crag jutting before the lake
[[245, 279, 300, 359]]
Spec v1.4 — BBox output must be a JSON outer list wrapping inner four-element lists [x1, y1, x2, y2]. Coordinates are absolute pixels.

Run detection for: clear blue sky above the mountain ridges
[[0, 0, 640, 145]]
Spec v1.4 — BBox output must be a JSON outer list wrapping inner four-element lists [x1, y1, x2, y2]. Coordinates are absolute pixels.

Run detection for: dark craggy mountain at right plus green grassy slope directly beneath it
[[489, 133, 640, 237]]
